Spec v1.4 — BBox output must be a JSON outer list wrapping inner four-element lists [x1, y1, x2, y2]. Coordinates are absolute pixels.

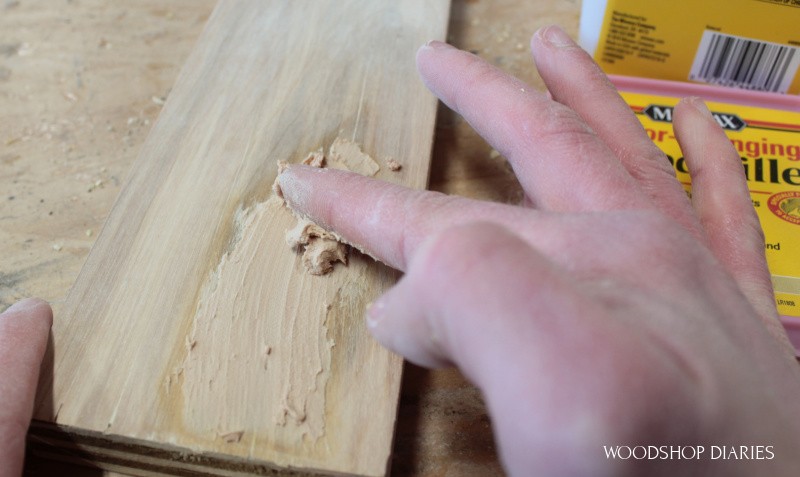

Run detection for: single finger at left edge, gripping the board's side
[[0, 299, 53, 477]]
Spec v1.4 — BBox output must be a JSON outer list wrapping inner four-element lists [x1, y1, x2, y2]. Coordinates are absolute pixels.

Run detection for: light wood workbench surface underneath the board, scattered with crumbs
[[0, 0, 580, 476]]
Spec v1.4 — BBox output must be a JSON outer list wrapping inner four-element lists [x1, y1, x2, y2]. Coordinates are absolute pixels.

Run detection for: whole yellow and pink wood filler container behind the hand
[[579, 0, 800, 356]]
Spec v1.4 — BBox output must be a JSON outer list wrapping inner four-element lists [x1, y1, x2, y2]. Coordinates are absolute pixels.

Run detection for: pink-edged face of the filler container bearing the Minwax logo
[[611, 75, 800, 356]]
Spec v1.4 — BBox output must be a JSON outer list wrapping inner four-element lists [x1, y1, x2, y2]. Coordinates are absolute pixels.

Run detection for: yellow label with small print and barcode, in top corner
[[594, 0, 800, 94]]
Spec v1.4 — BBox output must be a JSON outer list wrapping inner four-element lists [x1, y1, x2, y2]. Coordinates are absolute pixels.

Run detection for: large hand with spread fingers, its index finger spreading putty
[[280, 27, 800, 476]]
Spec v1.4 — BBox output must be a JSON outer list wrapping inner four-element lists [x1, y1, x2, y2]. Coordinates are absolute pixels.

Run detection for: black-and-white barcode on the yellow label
[[689, 30, 800, 93]]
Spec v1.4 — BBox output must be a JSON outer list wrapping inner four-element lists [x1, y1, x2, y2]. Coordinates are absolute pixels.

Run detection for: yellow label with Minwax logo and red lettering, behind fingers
[[621, 92, 800, 317]]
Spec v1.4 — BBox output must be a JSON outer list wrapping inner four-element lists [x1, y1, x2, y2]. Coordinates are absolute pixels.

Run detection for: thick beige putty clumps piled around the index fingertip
[[272, 138, 380, 275]]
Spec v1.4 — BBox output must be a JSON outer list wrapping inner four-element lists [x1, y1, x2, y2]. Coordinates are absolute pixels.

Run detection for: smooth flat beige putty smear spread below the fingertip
[[177, 197, 334, 440]]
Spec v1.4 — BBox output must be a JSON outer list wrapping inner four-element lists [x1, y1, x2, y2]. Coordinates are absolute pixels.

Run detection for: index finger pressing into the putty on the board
[[278, 165, 540, 270]]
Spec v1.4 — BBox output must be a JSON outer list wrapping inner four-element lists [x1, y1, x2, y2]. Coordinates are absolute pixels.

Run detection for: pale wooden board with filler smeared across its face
[[32, 0, 448, 475]]
